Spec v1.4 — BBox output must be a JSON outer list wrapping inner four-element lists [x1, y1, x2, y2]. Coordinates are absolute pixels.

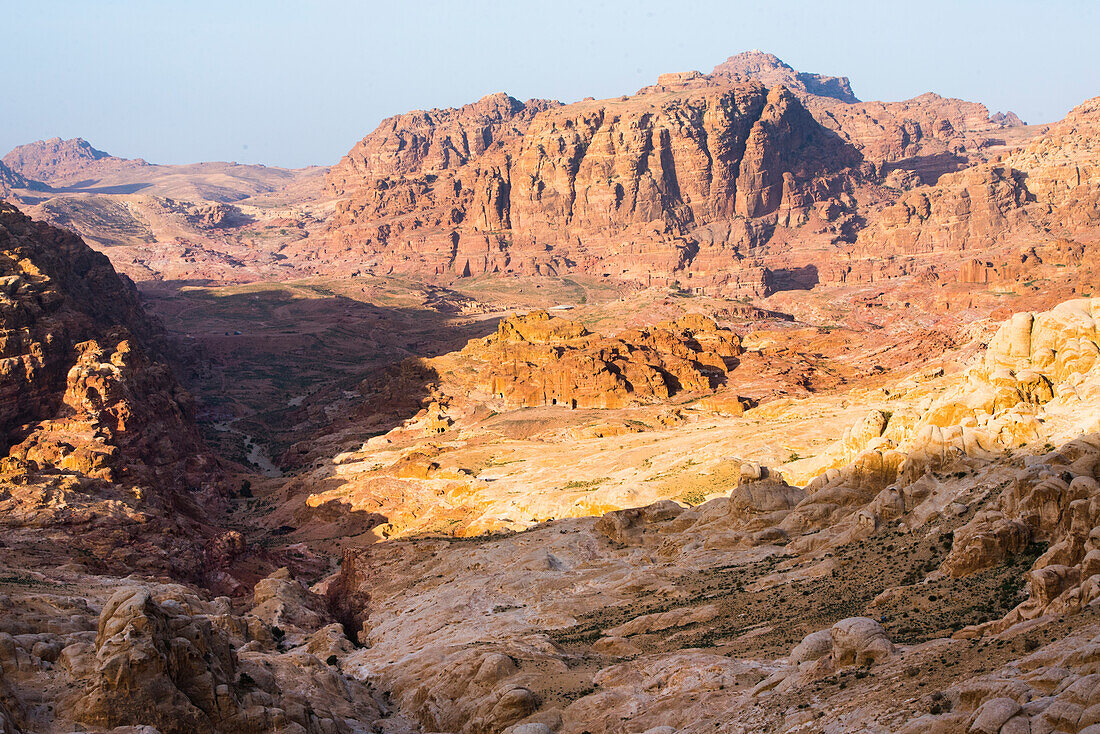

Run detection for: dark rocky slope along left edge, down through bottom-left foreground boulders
[[0, 202, 422, 734]]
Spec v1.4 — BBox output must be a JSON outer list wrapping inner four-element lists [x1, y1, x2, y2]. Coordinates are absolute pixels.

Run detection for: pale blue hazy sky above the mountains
[[0, 0, 1100, 167]]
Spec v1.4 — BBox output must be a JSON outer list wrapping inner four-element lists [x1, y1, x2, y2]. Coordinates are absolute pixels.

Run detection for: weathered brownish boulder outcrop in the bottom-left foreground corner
[[0, 572, 391, 734]]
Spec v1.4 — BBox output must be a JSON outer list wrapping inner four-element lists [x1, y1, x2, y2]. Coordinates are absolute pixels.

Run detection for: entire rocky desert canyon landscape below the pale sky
[[0, 52, 1100, 734]]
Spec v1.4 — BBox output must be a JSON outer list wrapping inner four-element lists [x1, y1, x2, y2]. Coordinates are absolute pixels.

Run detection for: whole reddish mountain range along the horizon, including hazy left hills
[[0, 52, 1064, 305]]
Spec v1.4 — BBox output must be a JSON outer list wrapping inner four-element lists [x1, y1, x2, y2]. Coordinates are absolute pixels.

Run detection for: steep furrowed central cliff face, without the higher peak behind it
[[310, 68, 861, 278]]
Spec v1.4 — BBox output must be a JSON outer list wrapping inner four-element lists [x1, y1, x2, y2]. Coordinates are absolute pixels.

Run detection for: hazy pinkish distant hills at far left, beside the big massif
[[0, 138, 327, 281]]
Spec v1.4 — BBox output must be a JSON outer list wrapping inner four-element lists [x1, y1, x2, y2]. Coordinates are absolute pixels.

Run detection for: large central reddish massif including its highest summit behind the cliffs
[[297, 52, 1051, 295]]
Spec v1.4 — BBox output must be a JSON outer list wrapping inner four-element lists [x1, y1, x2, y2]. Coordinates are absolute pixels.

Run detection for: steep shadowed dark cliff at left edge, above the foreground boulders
[[0, 205, 221, 574]]
